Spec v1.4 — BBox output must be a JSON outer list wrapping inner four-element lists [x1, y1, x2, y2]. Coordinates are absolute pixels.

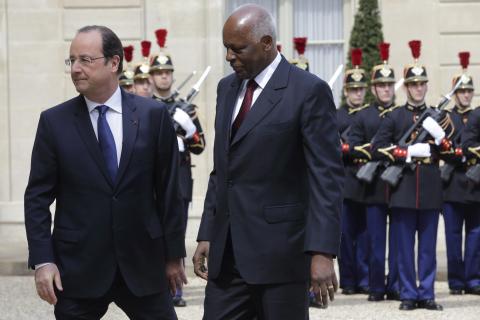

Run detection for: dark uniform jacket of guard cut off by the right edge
[[462, 108, 480, 202]]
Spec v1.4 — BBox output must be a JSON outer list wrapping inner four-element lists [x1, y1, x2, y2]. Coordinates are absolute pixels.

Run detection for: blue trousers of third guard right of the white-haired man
[[391, 208, 439, 300]]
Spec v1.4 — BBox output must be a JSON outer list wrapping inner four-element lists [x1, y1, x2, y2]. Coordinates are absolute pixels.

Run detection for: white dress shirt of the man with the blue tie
[[84, 87, 123, 165]]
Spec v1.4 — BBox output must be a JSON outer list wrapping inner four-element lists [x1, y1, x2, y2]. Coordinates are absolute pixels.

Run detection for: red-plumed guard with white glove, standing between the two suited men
[[149, 29, 205, 307]]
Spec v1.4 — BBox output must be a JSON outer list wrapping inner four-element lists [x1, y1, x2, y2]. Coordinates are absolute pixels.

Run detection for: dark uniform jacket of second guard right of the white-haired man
[[349, 103, 390, 204]]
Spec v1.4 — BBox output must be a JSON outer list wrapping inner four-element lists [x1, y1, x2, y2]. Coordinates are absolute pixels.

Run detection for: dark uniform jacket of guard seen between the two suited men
[[153, 95, 205, 202]]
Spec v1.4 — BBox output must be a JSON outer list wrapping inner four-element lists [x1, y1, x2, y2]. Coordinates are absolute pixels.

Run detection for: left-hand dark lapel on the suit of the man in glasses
[[75, 95, 113, 187]]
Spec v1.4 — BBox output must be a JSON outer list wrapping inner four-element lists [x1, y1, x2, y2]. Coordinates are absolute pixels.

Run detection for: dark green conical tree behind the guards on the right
[[342, 0, 383, 103]]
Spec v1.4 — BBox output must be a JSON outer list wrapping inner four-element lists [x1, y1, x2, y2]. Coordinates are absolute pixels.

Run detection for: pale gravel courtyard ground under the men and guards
[[0, 276, 480, 320]]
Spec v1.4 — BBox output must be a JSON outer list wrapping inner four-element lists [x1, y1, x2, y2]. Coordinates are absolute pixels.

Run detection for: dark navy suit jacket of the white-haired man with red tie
[[198, 58, 343, 284]]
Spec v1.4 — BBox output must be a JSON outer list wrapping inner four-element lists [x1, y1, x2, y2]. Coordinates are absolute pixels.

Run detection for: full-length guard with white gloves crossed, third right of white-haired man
[[373, 40, 451, 310]]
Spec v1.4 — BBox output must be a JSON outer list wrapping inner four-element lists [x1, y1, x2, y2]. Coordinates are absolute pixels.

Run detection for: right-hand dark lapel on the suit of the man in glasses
[[115, 90, 139, 190]]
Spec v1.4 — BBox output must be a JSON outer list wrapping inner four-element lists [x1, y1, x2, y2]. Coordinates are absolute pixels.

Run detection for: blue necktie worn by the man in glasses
[[95, 105, 118, 182]]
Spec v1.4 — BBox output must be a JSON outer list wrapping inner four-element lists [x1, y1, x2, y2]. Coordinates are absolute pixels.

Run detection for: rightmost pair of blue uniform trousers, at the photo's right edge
[[443, 202, 480, 289]]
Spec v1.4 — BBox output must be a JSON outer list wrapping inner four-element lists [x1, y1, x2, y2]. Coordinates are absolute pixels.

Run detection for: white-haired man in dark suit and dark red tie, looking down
[[193, 5, 343, 320]]
